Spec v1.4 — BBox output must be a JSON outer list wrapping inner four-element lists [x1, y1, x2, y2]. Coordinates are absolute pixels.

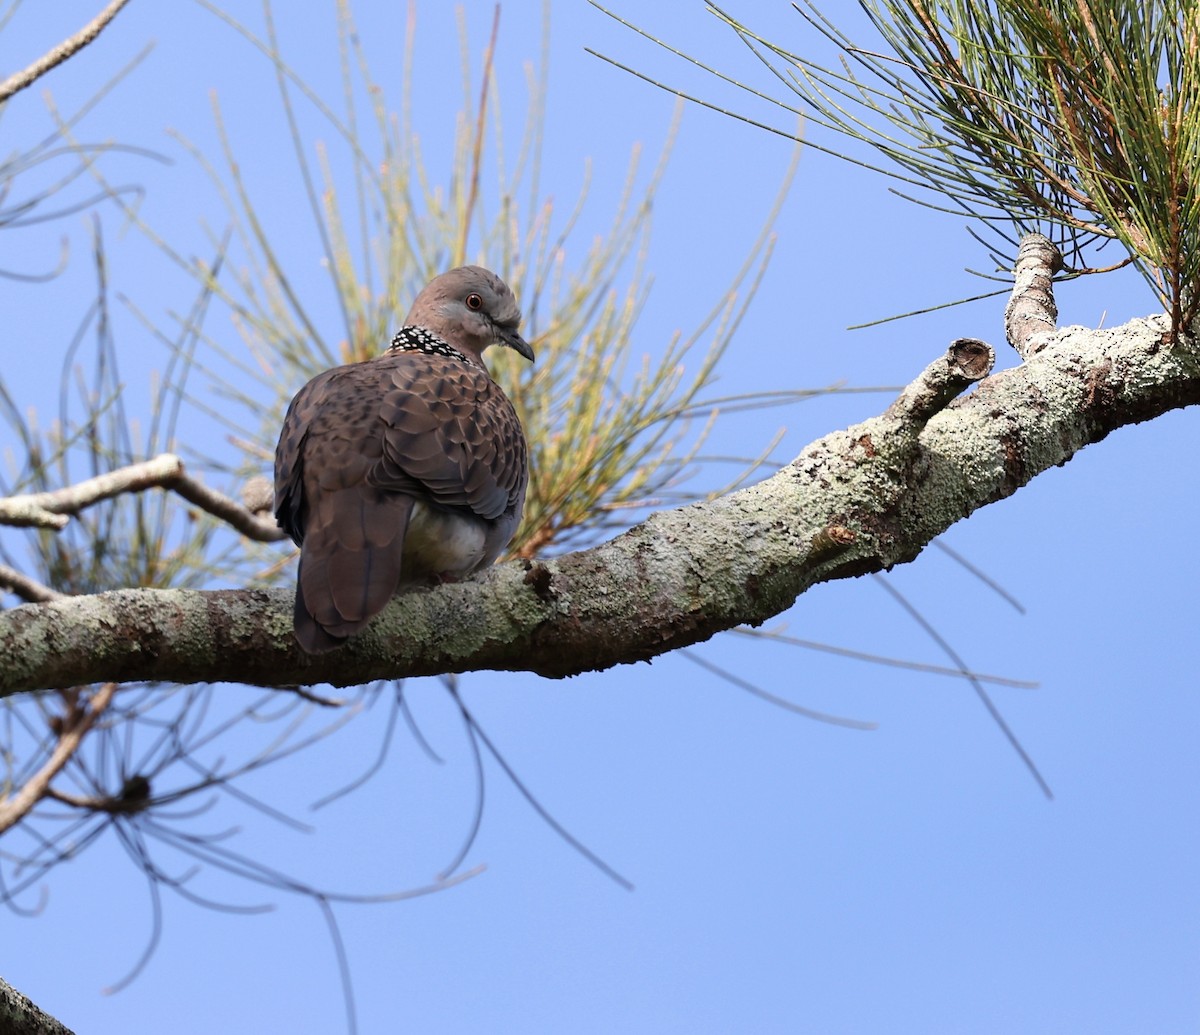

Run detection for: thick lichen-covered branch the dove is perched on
[[0, 300, 1200, 694]]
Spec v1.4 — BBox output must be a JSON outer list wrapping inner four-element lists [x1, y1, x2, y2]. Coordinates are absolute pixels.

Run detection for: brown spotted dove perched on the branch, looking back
[[275, 267, 533, 653]]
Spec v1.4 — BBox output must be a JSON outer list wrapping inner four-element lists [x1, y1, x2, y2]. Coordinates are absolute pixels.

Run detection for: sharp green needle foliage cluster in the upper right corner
[[595, 0, 1200, 329]]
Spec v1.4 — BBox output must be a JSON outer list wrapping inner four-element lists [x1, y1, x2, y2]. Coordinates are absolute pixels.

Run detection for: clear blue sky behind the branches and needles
[[0, 0, 1200, 1035]]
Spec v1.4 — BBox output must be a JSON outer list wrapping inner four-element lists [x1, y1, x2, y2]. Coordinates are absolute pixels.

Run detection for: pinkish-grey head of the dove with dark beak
[[404, 265, 533, 363]]
